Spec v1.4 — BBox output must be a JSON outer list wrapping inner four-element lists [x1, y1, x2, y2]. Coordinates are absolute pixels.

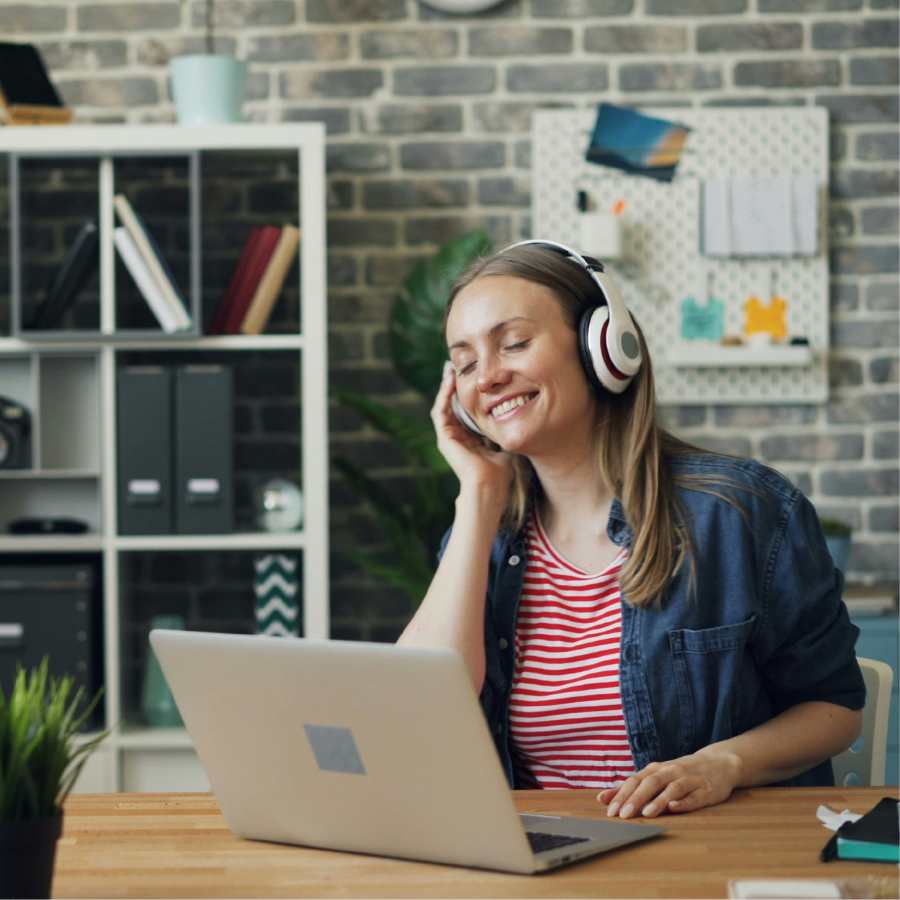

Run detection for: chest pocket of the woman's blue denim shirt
[[668, 613, 756, 756]]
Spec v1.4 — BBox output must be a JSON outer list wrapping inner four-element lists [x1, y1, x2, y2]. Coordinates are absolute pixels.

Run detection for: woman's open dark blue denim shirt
[[441, 454, 865, 787]]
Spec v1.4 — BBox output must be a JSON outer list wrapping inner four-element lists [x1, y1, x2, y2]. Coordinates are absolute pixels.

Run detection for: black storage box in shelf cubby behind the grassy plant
[[0, 563, 103, 727]]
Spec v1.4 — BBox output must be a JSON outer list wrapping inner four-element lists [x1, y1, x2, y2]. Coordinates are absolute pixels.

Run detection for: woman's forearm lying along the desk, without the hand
[[699, 701, 862, 787]]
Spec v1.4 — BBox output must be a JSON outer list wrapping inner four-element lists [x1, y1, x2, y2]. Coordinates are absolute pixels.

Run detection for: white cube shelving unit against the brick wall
[[0, 123, 329, 791]]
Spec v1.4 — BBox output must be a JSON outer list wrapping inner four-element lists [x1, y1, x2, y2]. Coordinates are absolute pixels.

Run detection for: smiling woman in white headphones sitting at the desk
[[400, 242, 865, 818]]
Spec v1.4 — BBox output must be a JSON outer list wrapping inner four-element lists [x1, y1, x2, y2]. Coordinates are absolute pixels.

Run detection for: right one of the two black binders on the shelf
[[175, 365, 234, 534]]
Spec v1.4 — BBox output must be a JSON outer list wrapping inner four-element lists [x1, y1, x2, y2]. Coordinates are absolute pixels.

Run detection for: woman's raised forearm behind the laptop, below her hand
[[398, 490, 502, 692]]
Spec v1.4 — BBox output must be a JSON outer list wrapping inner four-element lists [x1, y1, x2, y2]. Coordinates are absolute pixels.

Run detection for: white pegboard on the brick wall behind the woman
[[532, 108, 829, 404]]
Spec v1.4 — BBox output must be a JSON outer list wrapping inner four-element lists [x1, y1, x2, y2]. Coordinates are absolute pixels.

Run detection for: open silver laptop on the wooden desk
[[150, 629, 664, 874]]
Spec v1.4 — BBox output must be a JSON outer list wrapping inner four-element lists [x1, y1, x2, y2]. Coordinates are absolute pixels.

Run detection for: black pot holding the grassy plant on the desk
[[0, 813, 63, 897]]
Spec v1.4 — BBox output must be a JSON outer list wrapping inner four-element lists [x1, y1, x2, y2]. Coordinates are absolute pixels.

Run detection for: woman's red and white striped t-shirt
[[509, 515, 635, 788]]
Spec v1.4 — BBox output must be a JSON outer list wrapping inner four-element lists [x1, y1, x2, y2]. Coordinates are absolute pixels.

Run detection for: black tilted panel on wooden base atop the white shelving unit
[[0, 41, 72, 125]]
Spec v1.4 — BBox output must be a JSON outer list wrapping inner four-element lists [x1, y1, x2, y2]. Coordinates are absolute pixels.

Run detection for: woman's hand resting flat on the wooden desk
[[597, 747, 741, 819]]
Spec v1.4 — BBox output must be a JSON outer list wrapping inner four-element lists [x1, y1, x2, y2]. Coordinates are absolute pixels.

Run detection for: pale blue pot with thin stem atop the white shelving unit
[[169, 0, 247, 125]]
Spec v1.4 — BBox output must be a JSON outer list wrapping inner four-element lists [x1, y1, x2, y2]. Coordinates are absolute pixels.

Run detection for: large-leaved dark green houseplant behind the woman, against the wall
[[334, 231, 492, 606]]
